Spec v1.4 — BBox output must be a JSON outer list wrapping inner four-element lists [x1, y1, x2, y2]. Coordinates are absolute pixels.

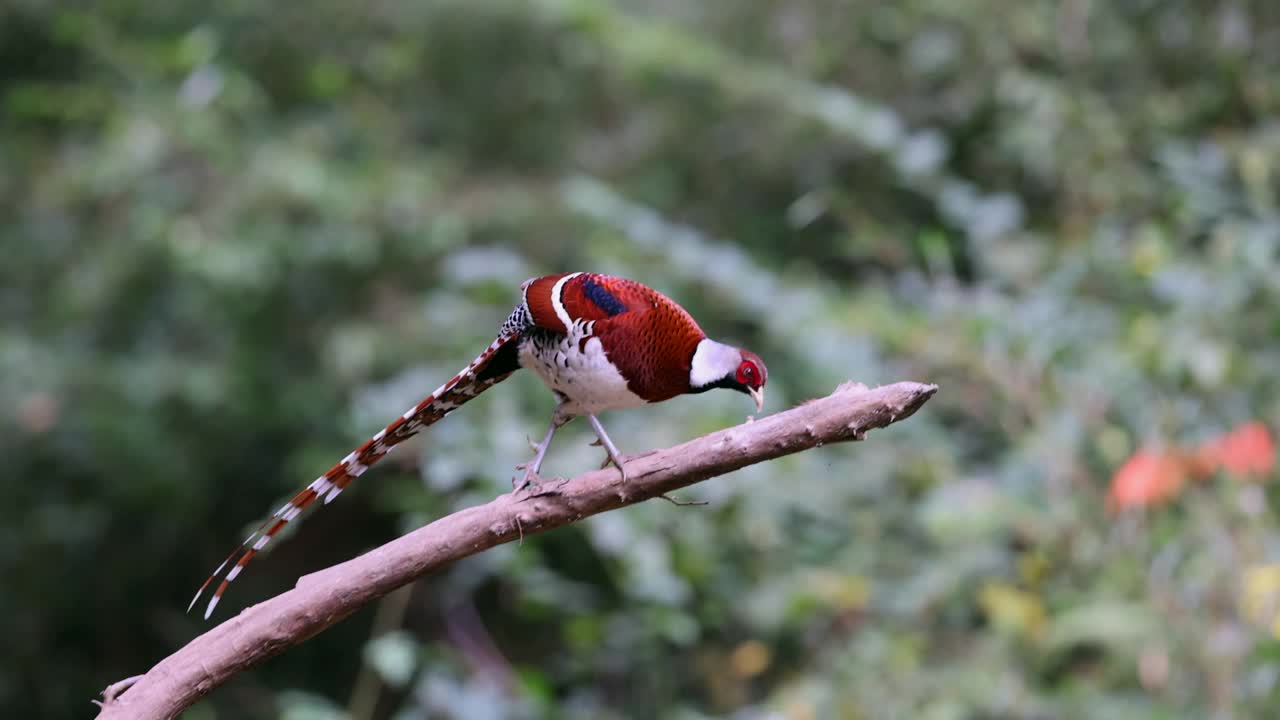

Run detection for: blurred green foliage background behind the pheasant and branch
[[0, 0, 1280, 720]]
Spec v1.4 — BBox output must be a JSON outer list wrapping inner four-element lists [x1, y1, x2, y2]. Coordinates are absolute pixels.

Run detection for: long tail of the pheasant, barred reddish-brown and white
[[187, 330, 524, 620]]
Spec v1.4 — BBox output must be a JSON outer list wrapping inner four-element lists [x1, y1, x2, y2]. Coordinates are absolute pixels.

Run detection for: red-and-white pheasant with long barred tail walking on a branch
[[187, 273, 768, 619]]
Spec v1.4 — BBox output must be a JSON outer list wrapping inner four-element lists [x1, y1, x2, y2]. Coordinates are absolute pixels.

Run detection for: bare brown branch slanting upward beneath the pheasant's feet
[[97, 383, 938, 720]]
